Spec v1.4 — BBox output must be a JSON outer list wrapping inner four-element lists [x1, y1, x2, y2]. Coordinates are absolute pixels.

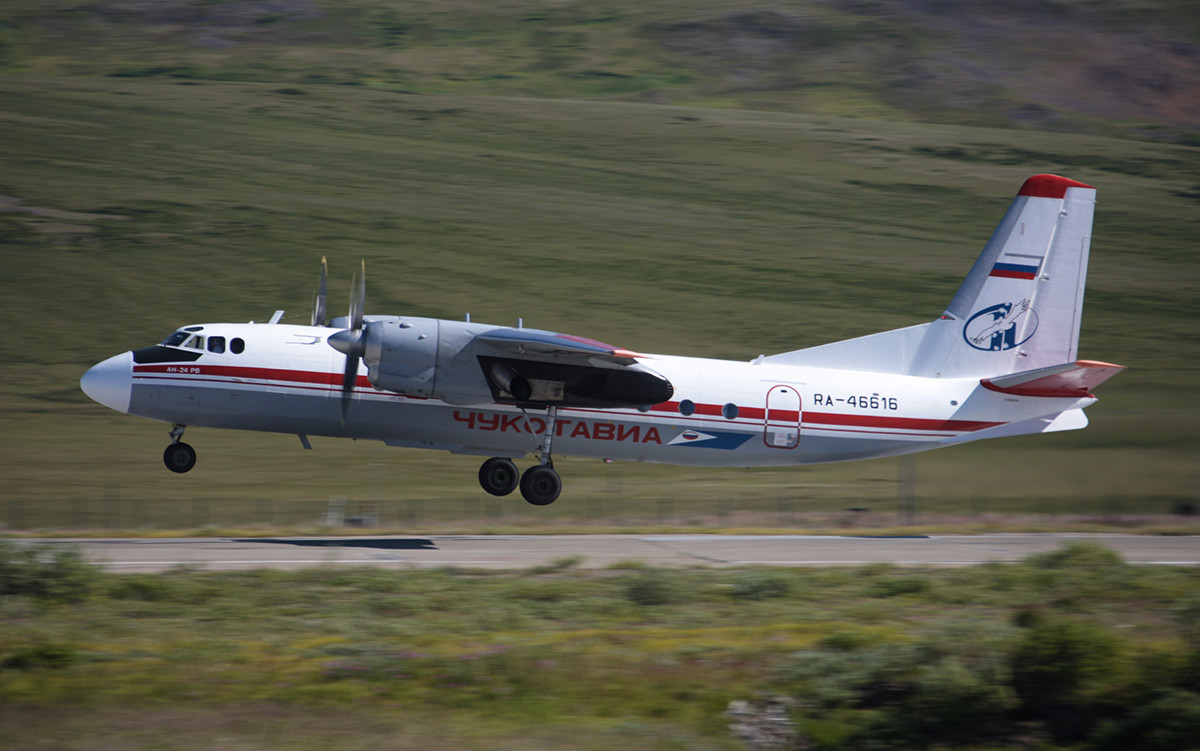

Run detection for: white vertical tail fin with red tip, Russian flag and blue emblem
[[764, 175, 1096, 378]]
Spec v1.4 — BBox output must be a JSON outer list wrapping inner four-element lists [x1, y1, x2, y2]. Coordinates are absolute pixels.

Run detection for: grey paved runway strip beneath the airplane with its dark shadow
[[23, 534, 1200, 572]]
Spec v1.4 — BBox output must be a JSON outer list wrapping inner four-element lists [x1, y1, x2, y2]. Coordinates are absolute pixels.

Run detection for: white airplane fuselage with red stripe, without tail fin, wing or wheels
[[83, 324, 1094, 467]]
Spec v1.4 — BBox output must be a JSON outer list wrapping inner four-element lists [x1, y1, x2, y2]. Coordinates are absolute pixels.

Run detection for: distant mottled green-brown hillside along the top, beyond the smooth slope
[[0, 0, 1200, 143]]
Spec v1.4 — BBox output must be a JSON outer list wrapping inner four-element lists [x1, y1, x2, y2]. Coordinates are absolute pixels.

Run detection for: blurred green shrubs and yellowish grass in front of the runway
[[0, 543, 1200, 751]]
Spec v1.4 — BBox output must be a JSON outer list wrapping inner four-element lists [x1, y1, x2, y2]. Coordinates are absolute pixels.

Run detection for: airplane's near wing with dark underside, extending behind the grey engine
[[475, 328, 674, 408]]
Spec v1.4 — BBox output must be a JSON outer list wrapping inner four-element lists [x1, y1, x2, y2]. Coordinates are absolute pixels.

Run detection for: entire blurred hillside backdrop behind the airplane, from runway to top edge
[[0, 0, 1200, 531]]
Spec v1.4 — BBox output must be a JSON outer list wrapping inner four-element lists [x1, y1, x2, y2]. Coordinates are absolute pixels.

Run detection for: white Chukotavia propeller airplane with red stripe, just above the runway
[[80, 175, 1122, 505]]
